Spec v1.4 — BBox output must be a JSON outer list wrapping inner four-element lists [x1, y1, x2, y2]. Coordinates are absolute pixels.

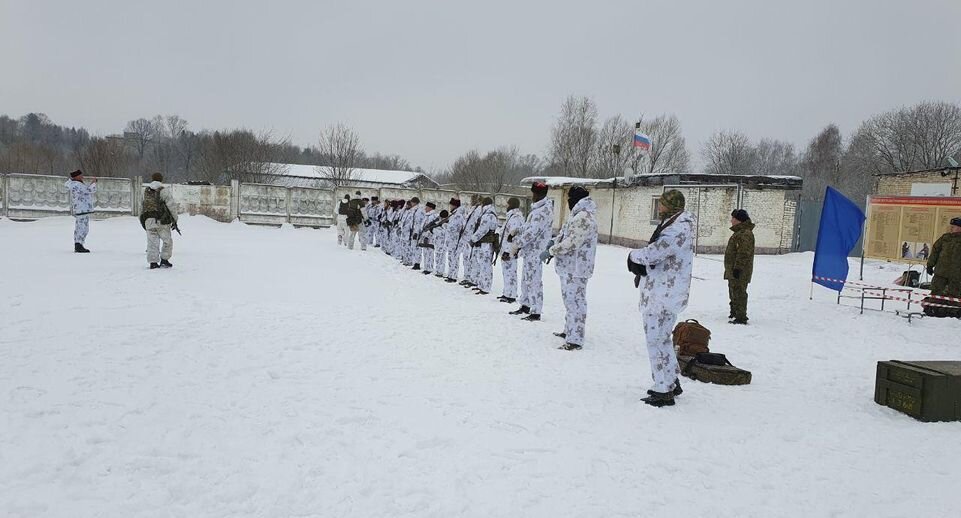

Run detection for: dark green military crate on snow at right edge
[[874, 360, 961, 421]]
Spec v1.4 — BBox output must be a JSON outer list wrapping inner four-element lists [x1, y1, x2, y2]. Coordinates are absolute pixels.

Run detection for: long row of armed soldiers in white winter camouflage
[[336, 183, 728, 407]]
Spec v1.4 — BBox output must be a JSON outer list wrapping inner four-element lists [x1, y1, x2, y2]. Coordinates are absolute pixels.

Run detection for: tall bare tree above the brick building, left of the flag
[[550, 96, 598, 178]]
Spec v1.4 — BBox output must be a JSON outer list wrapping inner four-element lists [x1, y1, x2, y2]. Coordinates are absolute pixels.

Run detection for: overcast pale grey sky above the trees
[[0, 0, 961, 169]]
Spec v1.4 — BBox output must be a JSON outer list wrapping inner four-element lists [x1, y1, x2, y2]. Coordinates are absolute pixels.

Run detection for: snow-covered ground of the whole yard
[[0, 217, 961, 517]]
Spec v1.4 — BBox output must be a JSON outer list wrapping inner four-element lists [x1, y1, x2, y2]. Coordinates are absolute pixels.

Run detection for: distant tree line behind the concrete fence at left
[[0, 113, 419, 183]]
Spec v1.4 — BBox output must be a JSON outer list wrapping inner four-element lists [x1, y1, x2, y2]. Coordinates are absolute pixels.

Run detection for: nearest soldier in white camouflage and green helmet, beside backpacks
[[627, 189, 695, 407]]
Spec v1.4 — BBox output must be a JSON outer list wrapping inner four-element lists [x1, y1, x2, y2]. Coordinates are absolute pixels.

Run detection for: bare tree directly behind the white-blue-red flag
[[629, 114, 691, 174]]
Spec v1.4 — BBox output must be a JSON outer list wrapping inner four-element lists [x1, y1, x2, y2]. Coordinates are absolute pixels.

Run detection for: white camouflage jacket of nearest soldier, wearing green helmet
[[630, 211, 696, 314]]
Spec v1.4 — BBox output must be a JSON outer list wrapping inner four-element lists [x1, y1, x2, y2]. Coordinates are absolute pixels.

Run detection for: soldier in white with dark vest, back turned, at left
[[140, 173, 177, 270]]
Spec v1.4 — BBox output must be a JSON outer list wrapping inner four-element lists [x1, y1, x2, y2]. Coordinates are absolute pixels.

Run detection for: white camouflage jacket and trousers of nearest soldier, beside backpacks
[[630, 212, 695, 392]]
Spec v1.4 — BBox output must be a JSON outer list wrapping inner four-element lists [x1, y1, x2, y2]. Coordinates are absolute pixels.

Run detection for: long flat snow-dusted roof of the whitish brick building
[[521, 173, 802, 189]]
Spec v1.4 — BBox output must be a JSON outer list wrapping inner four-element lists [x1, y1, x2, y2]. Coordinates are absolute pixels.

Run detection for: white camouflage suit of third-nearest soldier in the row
[[514, 197, 554, 315]]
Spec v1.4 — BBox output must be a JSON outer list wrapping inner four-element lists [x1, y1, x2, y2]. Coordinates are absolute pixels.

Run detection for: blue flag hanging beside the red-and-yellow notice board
[[812, 187, 864, 291]]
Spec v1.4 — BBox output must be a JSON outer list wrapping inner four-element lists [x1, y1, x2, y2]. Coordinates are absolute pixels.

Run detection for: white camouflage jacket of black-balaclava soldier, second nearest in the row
[[550, 198, 597, 278]]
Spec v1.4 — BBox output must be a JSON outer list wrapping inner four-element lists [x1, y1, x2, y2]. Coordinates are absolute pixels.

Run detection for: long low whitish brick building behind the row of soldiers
[[521, 174, 801, 254]]
